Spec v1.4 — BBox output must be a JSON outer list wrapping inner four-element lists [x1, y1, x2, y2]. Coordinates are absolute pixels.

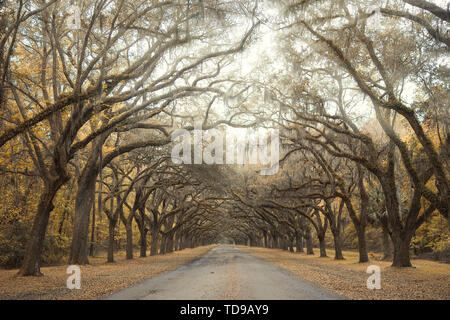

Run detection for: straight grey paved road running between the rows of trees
[[104, 245, 343, 300]]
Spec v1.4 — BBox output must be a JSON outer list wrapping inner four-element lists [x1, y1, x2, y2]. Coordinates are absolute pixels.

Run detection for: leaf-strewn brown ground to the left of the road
[[0, 245, 215, 300]]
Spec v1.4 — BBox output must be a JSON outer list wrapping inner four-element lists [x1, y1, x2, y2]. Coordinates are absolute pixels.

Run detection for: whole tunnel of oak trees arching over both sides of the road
[[0, 0, 450, 275]]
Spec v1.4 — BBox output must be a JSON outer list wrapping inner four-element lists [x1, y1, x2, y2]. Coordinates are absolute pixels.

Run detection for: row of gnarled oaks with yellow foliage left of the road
[[0, 0, 257, 275]]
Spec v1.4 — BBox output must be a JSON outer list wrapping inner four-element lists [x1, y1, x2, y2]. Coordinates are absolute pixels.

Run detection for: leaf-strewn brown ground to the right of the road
[[236, 246, 450, 300]]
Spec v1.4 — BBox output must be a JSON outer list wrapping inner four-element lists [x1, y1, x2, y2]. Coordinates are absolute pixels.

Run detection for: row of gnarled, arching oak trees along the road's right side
[[221, 1, 450, 267]]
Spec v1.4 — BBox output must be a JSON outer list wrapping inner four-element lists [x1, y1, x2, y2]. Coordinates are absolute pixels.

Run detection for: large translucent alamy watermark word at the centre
[[171, 122, 280, 175]]
